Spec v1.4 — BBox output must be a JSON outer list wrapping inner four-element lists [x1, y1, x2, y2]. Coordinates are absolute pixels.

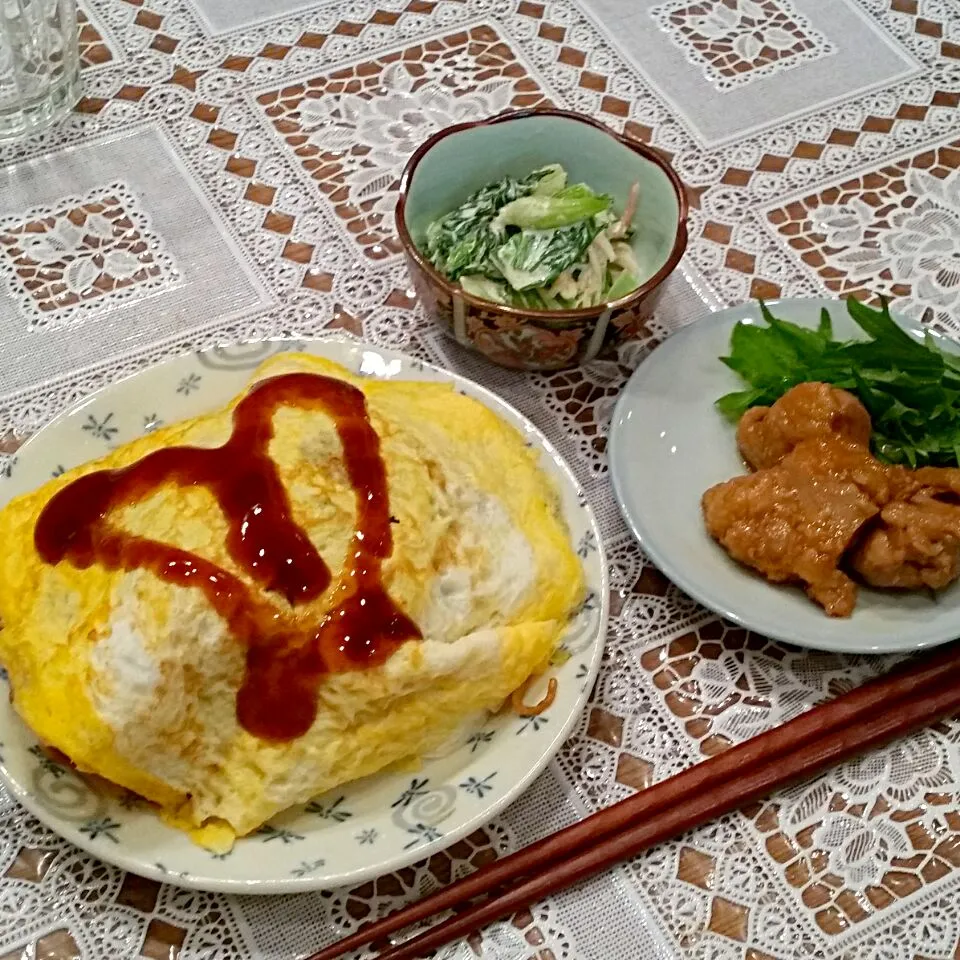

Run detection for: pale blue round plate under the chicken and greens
[[610, 299, 960, 653]]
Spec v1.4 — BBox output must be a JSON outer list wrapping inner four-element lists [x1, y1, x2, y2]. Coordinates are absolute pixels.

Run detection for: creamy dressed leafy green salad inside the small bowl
[[424, 164, 640, 310]]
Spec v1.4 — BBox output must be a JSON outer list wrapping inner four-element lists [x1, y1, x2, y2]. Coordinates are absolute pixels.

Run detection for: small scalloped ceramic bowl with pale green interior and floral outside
[[397, 110, 687, 370]]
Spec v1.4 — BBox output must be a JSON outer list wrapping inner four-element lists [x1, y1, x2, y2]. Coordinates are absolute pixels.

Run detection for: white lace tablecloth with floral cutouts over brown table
[[0, 0, 960, 960]]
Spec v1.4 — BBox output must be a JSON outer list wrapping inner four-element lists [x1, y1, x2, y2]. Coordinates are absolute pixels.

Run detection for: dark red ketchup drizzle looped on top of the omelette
[[34, 373, 420, 740]]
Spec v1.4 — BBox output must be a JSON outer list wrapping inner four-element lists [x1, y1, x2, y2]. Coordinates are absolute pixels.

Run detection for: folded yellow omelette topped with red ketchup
[[0, 354, 584, 850]]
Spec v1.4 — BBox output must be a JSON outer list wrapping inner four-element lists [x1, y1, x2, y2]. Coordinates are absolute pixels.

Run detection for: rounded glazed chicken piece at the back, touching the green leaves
[[737, 383, 871, 470]]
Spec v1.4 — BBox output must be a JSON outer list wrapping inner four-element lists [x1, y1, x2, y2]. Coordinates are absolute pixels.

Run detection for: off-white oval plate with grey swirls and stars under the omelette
[[0, 339, 607, 893]]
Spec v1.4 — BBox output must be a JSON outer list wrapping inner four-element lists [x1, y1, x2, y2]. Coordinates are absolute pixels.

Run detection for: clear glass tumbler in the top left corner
[[0, 0, 80, 140]]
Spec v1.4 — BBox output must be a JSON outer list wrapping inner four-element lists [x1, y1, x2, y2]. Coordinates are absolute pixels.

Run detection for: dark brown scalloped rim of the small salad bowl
[[396, 108, 689, 325]]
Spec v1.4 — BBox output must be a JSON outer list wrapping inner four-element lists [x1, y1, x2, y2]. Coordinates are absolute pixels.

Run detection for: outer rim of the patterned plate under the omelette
[[0, 331, 610, 896]]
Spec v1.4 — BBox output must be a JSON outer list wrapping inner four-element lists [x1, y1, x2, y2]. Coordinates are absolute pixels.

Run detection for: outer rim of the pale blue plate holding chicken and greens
[[608, 297, 960, 655]]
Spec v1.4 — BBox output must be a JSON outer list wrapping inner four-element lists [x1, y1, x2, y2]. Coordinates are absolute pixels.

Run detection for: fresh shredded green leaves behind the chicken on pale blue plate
[[717, 299, 960, 467]]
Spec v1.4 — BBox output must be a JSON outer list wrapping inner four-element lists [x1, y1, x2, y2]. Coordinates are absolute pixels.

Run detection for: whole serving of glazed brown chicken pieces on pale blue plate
[[703, 383, 960, 617]]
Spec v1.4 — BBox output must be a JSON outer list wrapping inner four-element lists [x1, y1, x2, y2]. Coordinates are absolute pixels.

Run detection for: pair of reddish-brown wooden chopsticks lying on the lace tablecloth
[[308, 646, 960, 960]]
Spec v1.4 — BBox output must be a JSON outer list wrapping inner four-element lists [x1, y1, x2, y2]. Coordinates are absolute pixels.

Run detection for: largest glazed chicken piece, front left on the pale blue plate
[[702, 438, 879, 617]]
